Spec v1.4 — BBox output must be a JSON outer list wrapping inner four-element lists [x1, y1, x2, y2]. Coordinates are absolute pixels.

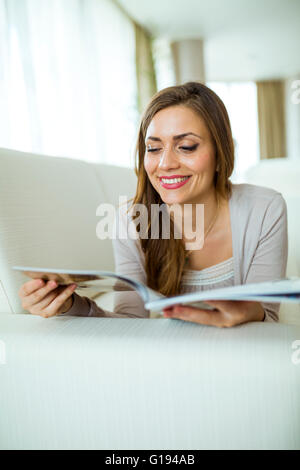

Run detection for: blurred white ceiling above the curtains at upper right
[[118, 0, 300, 81]]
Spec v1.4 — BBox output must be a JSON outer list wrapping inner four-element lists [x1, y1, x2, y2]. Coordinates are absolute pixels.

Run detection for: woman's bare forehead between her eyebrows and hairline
[[146, 106, 207, 139]]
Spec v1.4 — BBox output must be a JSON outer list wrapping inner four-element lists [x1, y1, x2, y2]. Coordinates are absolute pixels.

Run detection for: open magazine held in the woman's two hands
[[13, 266, 300, 312]]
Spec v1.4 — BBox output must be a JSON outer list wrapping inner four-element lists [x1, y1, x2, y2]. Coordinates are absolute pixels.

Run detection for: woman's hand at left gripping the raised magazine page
[[19, 279, 76, 318]]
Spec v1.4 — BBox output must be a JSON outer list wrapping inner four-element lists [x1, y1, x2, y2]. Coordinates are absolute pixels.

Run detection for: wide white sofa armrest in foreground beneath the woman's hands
[[0, 314, 300, 450]]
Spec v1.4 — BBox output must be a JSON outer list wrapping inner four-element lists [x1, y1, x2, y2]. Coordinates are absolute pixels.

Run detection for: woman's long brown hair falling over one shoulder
[[132, 82, 234, 296]]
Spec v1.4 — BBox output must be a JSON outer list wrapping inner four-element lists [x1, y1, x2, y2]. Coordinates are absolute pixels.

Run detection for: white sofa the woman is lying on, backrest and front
[[0, 149, 300, 450]]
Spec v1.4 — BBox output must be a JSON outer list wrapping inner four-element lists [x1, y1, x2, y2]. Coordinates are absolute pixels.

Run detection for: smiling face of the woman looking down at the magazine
[[144, 105, 216, 204]]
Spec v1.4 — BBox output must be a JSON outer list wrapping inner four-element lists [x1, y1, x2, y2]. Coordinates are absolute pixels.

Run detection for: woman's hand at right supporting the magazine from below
[[164, 300, 265, 328]]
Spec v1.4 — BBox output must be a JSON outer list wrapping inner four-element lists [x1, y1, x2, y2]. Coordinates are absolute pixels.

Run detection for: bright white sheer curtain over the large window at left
[[0, 0, 138, 166]]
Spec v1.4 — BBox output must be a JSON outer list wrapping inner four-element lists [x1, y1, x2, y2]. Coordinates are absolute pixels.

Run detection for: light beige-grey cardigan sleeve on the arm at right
[[245, 193, 288, 322]]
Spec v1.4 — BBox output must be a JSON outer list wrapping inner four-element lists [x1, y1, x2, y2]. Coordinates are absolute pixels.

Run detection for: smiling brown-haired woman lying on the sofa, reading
[[19, 82, 287, 327]]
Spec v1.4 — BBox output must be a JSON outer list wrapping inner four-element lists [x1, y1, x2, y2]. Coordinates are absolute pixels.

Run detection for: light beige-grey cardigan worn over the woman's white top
[[67, 184, 288, 321]]
